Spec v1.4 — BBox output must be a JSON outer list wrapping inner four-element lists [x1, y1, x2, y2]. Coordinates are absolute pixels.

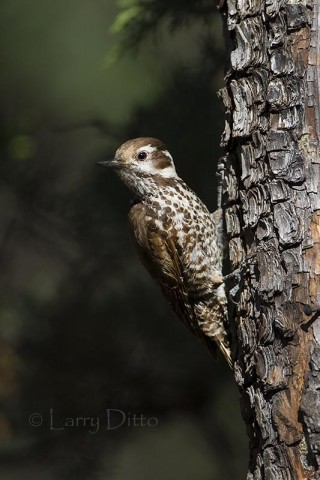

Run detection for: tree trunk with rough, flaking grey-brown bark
[[221, 0, 320, 480]]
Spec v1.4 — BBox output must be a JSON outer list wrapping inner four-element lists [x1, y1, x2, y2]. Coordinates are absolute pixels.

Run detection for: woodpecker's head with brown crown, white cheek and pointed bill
[[98, 137, 178, 196]]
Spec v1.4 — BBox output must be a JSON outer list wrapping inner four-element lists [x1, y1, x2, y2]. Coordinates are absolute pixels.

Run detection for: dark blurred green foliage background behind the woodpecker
[[0, 0, 246, 480]]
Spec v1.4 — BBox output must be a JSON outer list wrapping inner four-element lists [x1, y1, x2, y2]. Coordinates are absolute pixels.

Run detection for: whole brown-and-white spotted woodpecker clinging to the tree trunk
[[98, 137, 232, 367]]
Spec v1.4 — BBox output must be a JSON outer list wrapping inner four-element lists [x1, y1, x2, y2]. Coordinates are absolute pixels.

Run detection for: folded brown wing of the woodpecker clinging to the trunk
[[129, 203, 214, 351]]
